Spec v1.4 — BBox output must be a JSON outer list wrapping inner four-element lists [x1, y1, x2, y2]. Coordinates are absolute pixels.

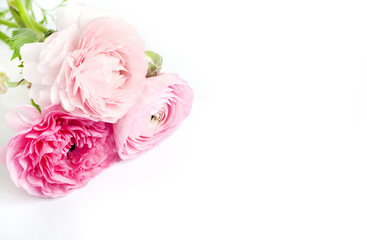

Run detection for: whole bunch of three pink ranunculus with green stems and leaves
[[0, 0, 193, 198]]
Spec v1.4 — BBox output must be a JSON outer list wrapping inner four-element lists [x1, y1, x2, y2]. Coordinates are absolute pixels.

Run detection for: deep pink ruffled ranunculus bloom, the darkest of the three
[[6, 105, 119, 198]]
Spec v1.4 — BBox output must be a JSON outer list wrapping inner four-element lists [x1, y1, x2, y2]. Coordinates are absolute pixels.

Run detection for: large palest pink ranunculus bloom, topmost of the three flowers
[[21, 4, 148, 123]]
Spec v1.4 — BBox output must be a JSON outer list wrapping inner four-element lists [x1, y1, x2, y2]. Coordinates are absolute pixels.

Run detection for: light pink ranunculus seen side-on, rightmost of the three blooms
[[113, 74, 193, 159]]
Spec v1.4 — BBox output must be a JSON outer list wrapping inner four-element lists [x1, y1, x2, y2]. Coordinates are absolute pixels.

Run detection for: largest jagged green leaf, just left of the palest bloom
[[9, 28, 43, 60]]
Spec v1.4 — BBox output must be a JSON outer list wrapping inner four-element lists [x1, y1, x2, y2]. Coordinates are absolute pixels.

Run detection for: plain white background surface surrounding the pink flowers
[[0, 0, 367, 240]]
